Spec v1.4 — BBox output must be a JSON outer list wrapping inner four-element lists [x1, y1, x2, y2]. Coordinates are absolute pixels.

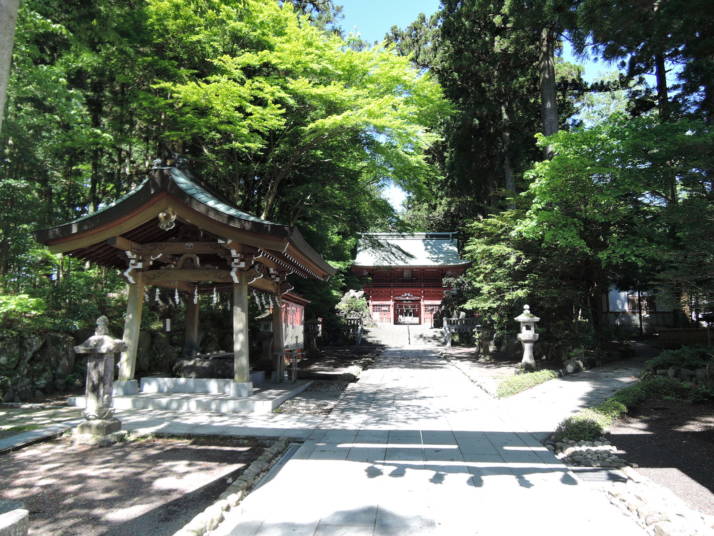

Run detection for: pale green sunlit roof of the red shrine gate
[[354, 233, 468, 266]]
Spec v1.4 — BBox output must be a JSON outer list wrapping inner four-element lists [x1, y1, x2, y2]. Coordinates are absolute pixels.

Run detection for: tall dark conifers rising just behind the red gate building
[[387, 0, 582, 224]]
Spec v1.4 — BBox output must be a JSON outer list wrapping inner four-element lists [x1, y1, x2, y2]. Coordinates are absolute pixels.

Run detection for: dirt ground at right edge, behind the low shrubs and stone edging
[[610, 400, 714, 515]]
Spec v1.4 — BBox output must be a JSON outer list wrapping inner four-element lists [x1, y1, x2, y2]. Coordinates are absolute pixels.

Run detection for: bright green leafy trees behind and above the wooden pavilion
[[0, 0, 450, 340]]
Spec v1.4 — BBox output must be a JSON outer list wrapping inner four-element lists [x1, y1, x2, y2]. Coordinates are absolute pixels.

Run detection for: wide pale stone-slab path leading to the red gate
[[213, 348, 644, 536]]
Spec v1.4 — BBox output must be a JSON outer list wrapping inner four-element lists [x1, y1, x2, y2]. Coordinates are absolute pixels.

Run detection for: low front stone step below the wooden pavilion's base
[[70, 381, 312, 413]]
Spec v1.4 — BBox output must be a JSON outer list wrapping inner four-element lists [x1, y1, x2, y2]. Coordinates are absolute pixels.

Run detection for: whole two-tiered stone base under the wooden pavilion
[[69, 377, 312, 413]]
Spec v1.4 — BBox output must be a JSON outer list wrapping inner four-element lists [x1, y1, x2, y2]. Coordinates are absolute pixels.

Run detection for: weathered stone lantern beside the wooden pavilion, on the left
[[74, 316, 127, 443]]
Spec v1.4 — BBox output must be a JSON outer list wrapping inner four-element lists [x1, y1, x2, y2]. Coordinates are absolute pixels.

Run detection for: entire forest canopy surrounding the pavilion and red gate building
[[0, 0, 714, 368]]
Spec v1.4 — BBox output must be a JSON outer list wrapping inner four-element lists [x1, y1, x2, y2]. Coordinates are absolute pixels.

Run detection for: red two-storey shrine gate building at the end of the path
[[352, 233, 469, 326]]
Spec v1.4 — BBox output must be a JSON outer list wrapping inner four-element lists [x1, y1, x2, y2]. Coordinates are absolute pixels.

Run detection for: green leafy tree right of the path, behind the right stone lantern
[[504, 114, 714, 337]]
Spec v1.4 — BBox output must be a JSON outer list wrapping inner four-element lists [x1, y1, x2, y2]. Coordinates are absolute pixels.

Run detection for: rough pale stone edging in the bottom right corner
[[607, 467, 714, 536]]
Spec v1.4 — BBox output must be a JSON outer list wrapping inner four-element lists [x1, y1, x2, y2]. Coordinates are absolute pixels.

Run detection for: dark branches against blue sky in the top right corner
[[570, 0, 714, 121]]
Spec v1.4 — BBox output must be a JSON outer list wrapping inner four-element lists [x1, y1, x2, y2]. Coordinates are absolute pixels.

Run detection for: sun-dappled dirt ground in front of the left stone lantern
[[0, 438, 264, 536]]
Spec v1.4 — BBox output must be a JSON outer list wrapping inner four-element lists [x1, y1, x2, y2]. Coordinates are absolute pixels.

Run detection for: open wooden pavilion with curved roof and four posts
[[36, 166, 335, 396]]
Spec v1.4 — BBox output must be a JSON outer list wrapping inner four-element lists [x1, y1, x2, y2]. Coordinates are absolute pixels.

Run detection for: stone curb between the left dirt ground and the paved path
[[173, 438, 291, 536]]
